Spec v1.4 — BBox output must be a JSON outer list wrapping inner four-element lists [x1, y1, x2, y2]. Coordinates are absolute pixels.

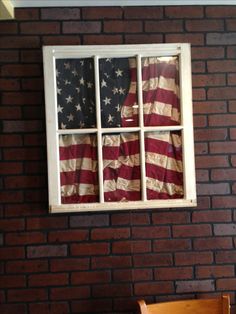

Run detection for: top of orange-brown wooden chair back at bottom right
[[138, 295, 230, 314]]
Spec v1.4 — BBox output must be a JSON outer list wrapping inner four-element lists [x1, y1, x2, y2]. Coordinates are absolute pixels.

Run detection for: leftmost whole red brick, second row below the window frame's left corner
[[6, 232, 47, 245]]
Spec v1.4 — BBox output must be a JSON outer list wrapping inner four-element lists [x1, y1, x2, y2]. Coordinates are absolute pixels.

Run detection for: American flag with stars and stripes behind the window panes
[[56, 57, 183, 203]]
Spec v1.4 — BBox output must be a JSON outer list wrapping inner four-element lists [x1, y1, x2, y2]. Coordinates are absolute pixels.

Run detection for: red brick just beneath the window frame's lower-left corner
[[27, 217, 67, 230]]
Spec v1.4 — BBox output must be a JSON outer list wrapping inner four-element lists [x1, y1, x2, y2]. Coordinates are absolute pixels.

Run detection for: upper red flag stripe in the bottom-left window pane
[[60, 144, 97, 160]]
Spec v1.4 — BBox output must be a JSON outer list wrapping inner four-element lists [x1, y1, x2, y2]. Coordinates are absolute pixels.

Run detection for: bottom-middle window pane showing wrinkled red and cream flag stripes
[[102, 133, 141, 202]]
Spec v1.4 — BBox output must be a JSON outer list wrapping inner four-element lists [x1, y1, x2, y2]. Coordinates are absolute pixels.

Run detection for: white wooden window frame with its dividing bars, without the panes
[[43, 43, 196, 213]]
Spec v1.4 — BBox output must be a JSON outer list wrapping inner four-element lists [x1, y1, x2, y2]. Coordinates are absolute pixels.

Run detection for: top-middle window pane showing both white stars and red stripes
[[99, 58, 138, 128]]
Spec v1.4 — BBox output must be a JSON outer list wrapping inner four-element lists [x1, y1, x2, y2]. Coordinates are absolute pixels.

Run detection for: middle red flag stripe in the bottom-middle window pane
[[103, 165, 140, 180]]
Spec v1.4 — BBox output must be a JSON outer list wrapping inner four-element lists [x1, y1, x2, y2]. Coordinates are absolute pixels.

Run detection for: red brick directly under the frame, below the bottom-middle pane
[[111, 213, 150, 226]]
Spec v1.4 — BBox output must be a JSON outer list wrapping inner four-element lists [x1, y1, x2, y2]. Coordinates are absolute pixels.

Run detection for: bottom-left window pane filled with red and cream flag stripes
[[59, 134, 99, 204]]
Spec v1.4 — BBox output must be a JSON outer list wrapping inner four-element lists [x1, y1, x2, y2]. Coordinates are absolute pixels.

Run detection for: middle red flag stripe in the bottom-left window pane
[[60, 170, 98, 185]]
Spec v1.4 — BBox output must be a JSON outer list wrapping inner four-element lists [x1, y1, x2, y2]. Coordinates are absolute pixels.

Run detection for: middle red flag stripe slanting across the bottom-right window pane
[[146, 163, 183, 186]]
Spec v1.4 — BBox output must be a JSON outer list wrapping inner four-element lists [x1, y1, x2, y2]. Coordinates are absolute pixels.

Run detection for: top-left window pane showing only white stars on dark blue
[[56, 58, 96, 129]]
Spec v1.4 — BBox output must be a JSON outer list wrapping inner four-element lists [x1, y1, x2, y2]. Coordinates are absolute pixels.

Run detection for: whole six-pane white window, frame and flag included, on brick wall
[[44, 44, 196, 212]]
